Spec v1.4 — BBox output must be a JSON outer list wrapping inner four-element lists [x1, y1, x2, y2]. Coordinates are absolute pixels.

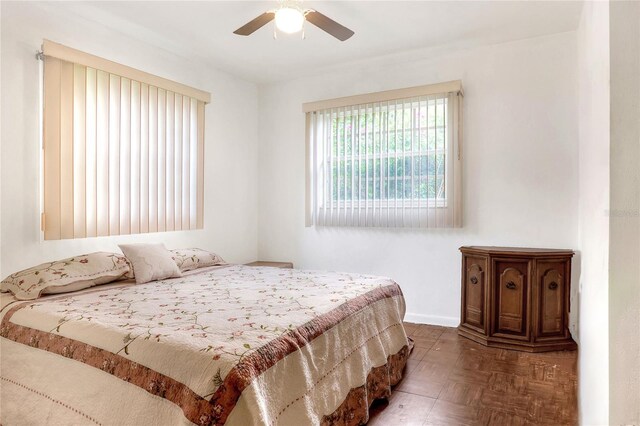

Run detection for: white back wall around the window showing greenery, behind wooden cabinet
[[258, 33, 578, 326]]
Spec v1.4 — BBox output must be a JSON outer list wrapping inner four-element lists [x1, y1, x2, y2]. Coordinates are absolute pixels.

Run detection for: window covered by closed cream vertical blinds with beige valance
[[43, 40, 210, 240]]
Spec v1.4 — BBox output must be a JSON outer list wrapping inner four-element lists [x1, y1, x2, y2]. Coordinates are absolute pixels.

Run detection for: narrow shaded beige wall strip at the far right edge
[[609, 1, 640, 425]]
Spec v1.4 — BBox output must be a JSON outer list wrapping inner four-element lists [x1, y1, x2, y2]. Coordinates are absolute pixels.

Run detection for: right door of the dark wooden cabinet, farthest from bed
[[534, 260, 569, 338]]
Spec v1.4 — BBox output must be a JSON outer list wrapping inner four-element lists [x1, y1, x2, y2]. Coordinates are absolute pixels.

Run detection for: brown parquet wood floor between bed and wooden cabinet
[[368, 323, 578, 426]]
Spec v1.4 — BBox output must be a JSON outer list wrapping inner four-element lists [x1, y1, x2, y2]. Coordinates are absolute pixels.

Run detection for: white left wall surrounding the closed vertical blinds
[[0, 2, 258, 276]]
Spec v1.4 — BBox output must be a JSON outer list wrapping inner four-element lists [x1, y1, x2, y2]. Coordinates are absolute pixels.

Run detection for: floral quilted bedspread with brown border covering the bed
[[0, 265, 411, 426]]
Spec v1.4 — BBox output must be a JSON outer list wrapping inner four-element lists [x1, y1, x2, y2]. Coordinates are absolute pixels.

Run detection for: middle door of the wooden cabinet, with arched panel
[[492, 259, 531, 340]]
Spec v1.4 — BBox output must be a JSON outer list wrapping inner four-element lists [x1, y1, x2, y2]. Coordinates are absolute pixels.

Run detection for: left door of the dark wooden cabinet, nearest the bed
[[462, 255, 487, 334]]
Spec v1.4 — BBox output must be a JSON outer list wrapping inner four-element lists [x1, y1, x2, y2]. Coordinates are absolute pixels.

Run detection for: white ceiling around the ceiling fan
[[38, 0, 582, 83]]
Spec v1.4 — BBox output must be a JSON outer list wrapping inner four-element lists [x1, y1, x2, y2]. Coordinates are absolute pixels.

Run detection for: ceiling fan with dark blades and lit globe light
[[233, 1, 355, 41]]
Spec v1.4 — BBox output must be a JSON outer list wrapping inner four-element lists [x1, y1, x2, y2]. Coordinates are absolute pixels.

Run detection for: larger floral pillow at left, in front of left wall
[[0, 252, 133, 300]]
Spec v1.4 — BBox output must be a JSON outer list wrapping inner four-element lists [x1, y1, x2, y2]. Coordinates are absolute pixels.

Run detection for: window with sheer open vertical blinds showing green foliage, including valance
[[304, 82, 462, 228]]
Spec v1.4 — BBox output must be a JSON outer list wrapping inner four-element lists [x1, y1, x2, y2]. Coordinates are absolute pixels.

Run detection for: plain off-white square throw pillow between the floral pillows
[[119, 243, 182, 284]]
